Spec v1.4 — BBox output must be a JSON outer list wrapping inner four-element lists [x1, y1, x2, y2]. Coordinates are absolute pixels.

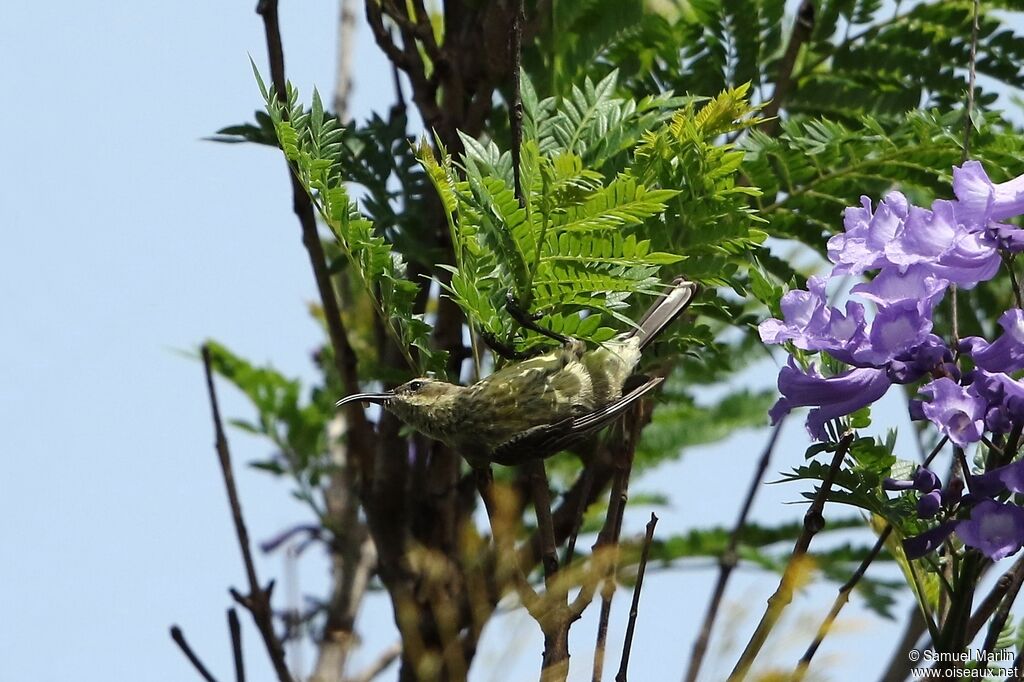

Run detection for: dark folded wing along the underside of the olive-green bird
[[489, 377, 664, 466]]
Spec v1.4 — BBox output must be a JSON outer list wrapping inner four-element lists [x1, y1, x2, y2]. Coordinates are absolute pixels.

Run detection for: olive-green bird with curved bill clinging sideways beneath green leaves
[[336, 278, 697, 468]]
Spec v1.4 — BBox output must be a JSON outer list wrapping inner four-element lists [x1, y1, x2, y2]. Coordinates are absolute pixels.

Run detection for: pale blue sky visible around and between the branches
[[0, 0, 962, 682]]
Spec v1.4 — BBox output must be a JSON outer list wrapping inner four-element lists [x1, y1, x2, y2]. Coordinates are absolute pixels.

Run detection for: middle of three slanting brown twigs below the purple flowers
[[729, 431, 855, 682]]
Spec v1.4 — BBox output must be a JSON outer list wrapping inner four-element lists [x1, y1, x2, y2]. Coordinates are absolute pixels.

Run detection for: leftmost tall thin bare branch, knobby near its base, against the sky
[[203, 346, 292, 682]]
